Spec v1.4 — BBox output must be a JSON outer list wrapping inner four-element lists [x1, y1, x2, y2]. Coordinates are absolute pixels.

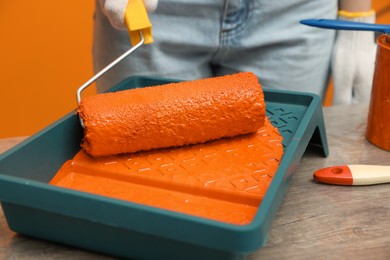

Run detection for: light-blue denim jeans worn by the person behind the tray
[[93, 0, 337, 96]]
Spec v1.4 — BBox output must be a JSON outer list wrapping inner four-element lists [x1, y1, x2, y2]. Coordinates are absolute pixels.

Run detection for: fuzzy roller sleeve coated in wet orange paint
[[78, 72, 265, 157]]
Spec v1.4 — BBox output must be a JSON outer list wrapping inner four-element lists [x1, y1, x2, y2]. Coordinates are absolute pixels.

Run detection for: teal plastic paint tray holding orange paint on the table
[[0, 77, 328, 259]]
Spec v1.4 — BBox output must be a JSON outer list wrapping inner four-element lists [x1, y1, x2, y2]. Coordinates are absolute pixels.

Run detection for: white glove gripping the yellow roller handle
[[99, 0, 158, 30]]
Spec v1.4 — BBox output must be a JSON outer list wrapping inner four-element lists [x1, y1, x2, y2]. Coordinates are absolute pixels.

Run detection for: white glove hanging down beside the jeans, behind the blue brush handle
[[332, 11, 376, 105]]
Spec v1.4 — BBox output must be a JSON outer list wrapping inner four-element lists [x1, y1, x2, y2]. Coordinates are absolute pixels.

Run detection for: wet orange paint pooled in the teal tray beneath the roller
[[50, 72, 283, 225]]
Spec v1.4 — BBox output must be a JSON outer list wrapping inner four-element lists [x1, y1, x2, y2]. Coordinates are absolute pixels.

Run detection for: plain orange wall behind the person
[[0, 0, 390, 138]]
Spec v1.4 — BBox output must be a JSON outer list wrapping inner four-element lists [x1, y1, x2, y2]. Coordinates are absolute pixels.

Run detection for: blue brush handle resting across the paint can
[[301, 19, 390, 33]]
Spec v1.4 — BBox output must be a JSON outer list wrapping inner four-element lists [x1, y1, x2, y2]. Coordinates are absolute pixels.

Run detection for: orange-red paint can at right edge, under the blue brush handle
[[366, 34, 390, 151]]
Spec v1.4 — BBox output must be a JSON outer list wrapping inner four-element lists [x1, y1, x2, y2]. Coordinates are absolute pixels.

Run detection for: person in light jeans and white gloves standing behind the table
[[93, 0, 375, 104]]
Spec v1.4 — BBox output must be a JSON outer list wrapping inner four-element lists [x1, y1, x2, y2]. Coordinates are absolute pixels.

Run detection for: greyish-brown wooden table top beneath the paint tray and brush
[[0, 105, 390, 259]]
